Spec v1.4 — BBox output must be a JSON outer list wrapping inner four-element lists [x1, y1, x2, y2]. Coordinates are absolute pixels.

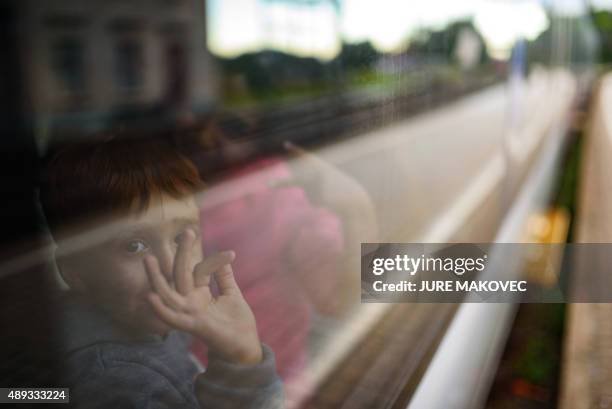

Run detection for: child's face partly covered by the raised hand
[[65, 195, 202, 334]]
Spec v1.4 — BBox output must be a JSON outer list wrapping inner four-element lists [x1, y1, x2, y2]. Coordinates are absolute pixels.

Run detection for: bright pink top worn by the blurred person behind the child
[[196, 158, 344, 380]]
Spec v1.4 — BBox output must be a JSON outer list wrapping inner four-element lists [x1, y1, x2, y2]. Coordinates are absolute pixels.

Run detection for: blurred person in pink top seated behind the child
[[178, 112, 376, 396]]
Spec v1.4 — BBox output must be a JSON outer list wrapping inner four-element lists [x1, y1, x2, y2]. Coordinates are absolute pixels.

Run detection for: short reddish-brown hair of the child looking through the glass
[[40, 137, 202, 237]]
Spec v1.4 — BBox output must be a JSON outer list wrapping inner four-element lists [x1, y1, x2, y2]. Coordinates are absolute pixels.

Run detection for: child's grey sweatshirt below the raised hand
[[63, 297, 283, 409]]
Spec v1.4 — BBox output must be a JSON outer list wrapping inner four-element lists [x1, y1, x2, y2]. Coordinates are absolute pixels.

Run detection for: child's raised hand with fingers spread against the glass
[[144, 229, 262, 364]]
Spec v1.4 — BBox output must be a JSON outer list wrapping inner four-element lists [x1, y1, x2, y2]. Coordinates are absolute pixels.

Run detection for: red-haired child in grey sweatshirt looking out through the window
[[41, 139, 282, 409]]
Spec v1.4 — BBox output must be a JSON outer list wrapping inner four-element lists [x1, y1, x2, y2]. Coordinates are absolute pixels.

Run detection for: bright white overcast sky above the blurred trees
[[207, 0, 580, 60]]
